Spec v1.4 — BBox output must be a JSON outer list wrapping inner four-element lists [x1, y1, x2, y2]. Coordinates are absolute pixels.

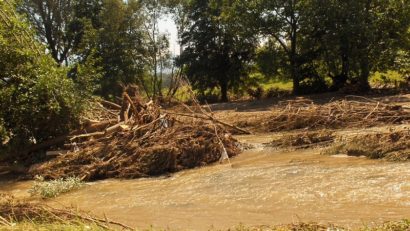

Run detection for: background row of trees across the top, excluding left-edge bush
[[16, 0, 410, 101]]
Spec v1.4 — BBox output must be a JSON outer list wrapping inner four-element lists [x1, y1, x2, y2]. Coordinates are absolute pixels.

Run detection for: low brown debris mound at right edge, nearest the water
[[323, 130, 410, 161]]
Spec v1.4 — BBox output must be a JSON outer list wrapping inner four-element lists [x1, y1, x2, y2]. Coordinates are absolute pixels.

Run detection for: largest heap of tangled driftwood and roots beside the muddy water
[[29, 89, 240, 181]]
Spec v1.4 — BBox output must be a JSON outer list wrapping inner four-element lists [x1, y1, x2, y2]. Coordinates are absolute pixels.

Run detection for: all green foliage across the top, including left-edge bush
[[0, 0, 410, 154]]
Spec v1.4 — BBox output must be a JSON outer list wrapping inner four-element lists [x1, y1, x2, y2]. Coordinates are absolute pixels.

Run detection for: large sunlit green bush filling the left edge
[[0, 1, 84, 156]]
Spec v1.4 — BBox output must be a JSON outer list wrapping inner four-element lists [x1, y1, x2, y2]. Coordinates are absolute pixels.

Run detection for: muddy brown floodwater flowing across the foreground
[[0, 134, 410, 230]]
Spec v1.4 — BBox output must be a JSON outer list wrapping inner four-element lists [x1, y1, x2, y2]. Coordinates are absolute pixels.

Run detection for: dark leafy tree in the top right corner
[[305, 0, 410, 90]]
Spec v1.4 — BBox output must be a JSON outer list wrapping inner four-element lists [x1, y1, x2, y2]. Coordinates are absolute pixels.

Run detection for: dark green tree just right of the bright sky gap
[[179, 0, 255, 101]]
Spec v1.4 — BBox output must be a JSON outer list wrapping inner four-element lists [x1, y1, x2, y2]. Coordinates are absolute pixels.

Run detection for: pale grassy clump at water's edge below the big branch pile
[[29, 176, 84, 198]]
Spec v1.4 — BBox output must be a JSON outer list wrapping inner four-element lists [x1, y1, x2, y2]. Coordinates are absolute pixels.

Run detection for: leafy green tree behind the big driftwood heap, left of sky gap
[[96, 0, 146, 97]]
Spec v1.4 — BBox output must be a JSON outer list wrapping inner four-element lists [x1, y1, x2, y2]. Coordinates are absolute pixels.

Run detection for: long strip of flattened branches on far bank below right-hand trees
[[264, 100, 410, 132]]
